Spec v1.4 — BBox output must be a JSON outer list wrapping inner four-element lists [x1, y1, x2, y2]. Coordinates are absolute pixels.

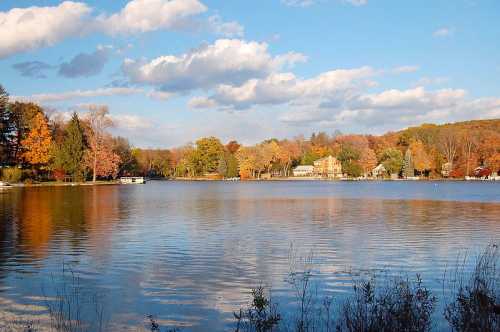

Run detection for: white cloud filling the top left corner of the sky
[[0, 1, 91, 58]]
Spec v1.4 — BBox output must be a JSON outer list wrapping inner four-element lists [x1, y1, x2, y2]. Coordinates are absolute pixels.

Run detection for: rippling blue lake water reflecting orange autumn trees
[[0, 181, 500, 331]]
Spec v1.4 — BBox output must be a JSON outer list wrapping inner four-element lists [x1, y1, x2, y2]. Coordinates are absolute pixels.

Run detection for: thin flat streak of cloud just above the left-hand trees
[[11, 88, 143, 103]]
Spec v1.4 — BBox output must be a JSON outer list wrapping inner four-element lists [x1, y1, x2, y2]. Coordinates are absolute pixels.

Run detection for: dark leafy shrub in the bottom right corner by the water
[[444, 245, 500, 332]]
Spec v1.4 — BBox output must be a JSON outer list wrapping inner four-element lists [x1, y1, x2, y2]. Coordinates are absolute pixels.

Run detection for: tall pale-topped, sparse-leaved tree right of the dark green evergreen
[[85, 105, 116, 182]]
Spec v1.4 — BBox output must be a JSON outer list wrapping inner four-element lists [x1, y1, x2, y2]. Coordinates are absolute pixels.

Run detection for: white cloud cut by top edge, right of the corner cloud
[[97, 0, 207, 35]]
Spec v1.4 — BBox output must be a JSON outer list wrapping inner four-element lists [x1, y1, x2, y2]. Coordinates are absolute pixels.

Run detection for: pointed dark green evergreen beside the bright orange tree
[[53, 113, 87, 181]]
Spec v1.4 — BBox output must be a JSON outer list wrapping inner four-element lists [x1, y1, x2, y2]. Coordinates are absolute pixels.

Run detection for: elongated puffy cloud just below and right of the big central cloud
[[189, 67, 376, 109]]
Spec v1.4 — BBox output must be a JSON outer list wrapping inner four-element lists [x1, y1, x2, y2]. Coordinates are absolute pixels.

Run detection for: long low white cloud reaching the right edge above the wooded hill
[[280, 87, 492, 132]]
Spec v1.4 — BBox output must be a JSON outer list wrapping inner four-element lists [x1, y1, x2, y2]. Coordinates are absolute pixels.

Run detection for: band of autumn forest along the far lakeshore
[[0, 82, 500, 183]]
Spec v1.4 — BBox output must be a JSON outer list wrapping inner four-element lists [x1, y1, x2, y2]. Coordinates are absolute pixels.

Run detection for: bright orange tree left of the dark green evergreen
[[21, 112, 52, 166]]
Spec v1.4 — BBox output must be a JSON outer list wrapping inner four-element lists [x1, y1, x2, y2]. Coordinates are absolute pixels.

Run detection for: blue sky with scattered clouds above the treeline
[[0, 0, 500, 148]]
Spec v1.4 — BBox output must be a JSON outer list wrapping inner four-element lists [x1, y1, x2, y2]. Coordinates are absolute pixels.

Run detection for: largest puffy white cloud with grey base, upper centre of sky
[[122, 39, 306, 92]]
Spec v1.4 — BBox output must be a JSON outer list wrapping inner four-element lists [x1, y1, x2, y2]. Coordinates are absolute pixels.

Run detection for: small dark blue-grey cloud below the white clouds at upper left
[[58, 46, 110, 78]]
